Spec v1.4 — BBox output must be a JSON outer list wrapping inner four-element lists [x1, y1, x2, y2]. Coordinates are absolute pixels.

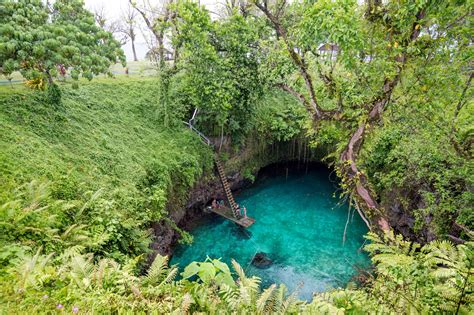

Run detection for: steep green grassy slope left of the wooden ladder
[[0, 79, 210, 259]]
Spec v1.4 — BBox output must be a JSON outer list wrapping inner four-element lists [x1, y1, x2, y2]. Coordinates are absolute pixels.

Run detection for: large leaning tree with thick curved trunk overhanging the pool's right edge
[[254, 0, 472, 235]]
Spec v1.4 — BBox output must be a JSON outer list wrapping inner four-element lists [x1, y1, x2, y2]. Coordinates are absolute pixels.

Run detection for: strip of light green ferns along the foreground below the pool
[[0, 233, 474, 314]]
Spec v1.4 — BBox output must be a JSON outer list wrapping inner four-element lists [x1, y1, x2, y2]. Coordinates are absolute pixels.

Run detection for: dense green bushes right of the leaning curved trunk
[[361, 42, 474, 235]]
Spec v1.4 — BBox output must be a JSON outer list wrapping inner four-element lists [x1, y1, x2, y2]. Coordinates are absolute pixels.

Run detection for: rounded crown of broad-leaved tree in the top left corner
[[0, 0, 125, 85]]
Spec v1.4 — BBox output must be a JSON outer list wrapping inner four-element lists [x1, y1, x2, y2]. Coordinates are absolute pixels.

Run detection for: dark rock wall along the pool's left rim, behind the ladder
[[148, 173, 251, 264]]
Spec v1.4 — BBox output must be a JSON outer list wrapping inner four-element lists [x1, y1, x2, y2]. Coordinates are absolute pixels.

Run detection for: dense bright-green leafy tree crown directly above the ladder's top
[[172, 1, 262, 142]]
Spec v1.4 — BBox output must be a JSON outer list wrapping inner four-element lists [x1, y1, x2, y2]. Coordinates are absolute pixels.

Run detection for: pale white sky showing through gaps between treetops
[[85, 0, 225, 60]]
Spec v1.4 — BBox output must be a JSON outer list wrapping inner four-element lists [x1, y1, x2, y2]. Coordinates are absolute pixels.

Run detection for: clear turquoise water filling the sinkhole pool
[[171, 167, 369, 300]]
